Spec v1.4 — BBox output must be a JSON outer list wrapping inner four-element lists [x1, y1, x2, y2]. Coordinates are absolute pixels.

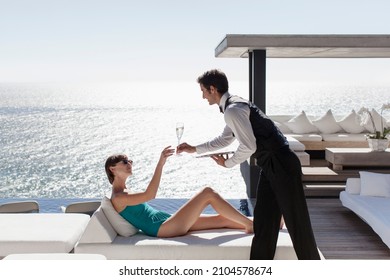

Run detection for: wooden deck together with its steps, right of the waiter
[[302, 159, 390, 259]]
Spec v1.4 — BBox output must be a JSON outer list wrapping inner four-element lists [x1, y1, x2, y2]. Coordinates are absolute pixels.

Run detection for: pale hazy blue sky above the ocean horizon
[[0, 0, 390, 83]]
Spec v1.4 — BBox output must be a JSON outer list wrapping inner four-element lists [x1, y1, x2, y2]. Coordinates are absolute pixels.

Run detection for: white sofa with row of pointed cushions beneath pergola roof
[[269, 110, 390, 151]]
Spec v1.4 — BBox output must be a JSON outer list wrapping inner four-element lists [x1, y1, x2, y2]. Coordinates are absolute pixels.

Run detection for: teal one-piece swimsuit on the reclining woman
[[119, 203, 171, 236]]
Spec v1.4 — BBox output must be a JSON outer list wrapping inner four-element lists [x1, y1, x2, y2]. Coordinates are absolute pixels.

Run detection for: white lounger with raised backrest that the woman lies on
[[74, 202, 322, 260]]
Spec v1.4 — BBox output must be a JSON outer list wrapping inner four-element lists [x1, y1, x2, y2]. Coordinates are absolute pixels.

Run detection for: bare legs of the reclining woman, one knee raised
[[158, 187, 253, 237]]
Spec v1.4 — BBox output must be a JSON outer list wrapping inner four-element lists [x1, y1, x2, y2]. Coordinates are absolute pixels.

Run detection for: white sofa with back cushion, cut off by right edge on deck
[[340, 172, 390, 248]]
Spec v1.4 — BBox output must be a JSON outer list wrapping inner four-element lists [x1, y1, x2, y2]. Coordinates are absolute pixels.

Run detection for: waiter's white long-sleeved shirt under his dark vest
[[195, 92, 257, 168]]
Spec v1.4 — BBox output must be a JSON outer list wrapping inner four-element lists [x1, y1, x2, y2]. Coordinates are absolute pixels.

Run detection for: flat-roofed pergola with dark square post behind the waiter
[[215, 34, 390, 197]]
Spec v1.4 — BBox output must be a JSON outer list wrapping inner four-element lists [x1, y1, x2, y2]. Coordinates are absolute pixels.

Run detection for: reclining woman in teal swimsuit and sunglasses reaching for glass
[[105, 146, 253, 237]]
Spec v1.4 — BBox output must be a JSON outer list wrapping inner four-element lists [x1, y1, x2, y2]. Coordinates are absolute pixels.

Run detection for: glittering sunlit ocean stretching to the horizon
[[0, 81, 390, 211]]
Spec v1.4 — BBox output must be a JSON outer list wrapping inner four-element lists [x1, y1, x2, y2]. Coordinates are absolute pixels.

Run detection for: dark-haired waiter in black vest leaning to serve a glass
[[177, 70, 320, 260]]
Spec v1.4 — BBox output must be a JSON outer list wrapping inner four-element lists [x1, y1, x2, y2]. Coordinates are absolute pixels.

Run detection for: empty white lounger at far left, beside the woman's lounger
[[0, 213, 90, 259]]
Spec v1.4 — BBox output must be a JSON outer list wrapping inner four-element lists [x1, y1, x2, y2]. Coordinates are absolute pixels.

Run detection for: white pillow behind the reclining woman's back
[[101, 196, 138, 237]]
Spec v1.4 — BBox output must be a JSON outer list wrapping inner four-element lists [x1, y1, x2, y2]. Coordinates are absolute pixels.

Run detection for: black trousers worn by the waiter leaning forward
[[250, 147, 320, 260]]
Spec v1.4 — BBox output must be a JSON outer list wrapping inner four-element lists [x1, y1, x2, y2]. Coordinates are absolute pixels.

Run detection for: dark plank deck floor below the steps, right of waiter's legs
[[307, 198, 390, 260]]
